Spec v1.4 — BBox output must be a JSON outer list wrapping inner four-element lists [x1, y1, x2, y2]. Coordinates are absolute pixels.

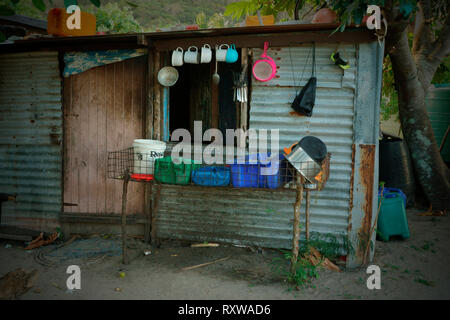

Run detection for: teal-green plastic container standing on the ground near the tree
[[377, 193, 409, 241]]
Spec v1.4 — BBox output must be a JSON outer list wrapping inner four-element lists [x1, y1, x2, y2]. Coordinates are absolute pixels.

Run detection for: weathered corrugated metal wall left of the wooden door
[[0, 52, 62, 231]]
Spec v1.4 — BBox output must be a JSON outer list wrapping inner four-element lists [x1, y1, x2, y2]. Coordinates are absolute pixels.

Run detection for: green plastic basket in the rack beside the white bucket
[[155, 157, 200, 184]]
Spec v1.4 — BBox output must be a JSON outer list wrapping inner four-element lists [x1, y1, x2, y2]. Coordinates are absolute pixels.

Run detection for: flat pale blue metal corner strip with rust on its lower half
[[347, 42, 384, 268]]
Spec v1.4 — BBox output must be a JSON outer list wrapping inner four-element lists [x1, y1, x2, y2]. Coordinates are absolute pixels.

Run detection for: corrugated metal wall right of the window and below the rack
[[157, 44, 356, 248]]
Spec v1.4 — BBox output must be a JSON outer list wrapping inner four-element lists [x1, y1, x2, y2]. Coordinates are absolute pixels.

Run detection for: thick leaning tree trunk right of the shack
[[387, 30, 450, 210]]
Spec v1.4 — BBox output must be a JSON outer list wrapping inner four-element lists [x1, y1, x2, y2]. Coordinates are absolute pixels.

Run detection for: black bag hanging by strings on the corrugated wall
[[291, 43, 317, 117]]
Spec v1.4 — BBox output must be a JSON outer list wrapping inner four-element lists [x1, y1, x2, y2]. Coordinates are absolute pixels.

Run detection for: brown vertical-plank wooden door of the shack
[[64, 57, 146, 214]]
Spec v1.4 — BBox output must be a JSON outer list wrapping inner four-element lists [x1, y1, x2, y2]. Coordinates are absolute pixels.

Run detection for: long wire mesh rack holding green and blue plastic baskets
[[107, 147, 330, 190]]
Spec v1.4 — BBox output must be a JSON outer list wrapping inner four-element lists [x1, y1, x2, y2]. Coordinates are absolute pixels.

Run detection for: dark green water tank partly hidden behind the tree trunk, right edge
[[425, 83, 450, 162]]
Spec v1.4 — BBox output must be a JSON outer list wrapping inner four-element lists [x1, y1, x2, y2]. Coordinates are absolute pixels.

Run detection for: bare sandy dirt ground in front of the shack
[[0, 209, 450, 300]]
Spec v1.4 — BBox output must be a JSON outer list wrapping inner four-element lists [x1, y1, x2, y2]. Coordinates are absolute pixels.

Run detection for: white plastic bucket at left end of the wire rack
[[133, 139, 166, 174]]
